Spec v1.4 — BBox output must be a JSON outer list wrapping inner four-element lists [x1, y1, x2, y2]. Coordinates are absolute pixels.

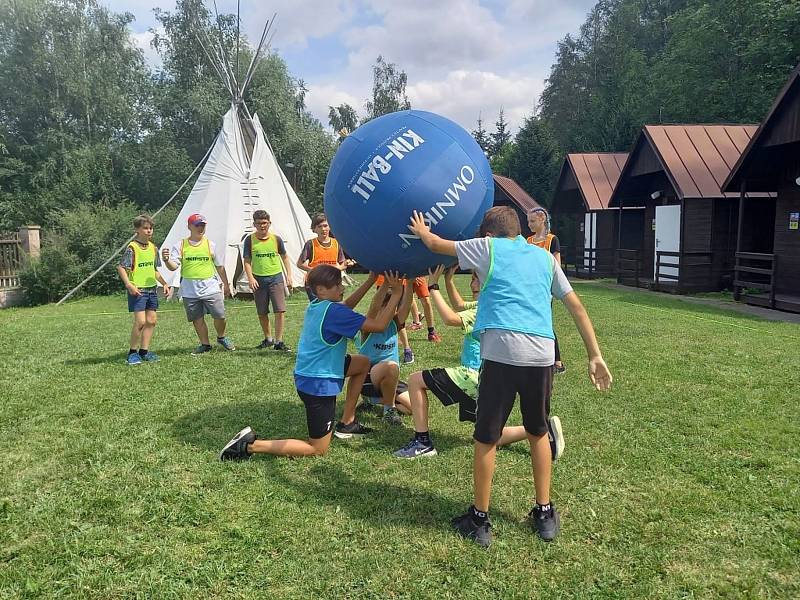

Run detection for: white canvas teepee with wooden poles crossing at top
[[160, 18, 314, 292]]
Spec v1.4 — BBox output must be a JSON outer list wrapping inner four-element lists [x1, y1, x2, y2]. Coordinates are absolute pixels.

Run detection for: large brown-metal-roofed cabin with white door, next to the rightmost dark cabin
[[609, 125, 766, 293]]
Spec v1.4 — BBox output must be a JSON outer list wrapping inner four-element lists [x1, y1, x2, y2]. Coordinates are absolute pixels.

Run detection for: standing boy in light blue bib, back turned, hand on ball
[[409, 206, 612, 547]]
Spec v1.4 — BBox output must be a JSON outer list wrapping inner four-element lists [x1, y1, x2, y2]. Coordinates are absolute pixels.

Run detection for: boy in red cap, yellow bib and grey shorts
[[161, 213, 236, 355]]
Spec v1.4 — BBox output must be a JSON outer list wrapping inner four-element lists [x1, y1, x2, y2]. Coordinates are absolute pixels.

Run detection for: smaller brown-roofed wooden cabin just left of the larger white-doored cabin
[[550, 152, 628, 278]]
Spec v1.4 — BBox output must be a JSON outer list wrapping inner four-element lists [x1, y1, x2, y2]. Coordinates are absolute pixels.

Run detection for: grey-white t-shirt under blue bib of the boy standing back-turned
[[456, 238, 572, 367]]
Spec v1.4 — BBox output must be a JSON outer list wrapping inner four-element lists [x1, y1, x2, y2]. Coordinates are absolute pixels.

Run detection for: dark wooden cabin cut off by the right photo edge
[[723, 65, 800, 312]]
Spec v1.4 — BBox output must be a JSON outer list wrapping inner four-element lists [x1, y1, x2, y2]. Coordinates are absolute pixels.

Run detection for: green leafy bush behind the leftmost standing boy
[[20, 202, 178, 305]]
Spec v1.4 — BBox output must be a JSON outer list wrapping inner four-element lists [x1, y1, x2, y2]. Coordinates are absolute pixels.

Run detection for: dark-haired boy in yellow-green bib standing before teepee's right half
[[242, 210, 292, 352]]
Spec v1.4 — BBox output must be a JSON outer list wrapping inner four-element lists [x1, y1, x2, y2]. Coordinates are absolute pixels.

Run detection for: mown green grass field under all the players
[[0, 280, 800, 598]]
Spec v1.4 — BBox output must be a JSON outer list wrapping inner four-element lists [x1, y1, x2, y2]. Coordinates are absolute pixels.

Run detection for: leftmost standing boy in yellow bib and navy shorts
[[117, 215, 169, 366]]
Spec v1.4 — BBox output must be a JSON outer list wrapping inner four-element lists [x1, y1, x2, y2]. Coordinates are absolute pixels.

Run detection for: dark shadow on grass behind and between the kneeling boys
[[172, 404, 472, 456]]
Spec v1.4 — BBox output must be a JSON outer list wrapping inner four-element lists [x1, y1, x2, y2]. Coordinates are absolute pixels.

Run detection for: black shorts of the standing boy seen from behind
[[473, 360, 553, 444]]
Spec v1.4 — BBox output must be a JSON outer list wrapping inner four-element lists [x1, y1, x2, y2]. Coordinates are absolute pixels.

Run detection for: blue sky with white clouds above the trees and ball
[[106, 0, 596, 131]]
